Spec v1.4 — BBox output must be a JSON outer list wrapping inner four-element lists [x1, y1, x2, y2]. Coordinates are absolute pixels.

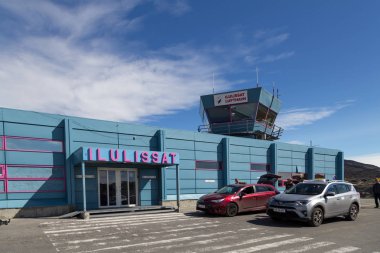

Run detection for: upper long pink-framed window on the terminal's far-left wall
[[4, 136, 63, 152]]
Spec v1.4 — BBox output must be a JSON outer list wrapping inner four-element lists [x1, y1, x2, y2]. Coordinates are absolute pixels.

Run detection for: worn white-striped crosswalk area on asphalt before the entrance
[[41, 213, 360, 253]]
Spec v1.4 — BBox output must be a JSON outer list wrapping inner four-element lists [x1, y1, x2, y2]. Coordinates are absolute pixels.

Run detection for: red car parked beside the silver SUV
[[197, 183, 279, 217]]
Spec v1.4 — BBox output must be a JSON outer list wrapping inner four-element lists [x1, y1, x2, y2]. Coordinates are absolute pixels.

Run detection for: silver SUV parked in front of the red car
[[267, 180, 360, 227]]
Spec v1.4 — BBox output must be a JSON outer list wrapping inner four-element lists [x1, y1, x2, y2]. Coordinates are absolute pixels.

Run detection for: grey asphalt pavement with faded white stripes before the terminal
[[0, 200, 380, 253]]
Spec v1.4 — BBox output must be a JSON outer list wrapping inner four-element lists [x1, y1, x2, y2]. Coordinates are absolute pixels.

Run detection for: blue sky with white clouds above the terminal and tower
[[0, 0, 380, 166]]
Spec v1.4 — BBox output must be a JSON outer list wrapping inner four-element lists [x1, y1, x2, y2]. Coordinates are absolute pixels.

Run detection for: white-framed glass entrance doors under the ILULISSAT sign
[[98, 168, 138, 208]]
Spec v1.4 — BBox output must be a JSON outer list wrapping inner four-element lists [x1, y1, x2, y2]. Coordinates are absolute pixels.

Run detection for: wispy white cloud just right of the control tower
[[277, 101, 350, 130]]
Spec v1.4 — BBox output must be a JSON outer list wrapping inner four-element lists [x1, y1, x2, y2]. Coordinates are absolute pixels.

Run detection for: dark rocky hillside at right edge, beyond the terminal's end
[[344, 160, 380, 197]]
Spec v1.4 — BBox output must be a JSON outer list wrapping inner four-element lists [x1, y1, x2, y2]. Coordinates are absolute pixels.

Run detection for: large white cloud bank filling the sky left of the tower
[[0, 1, 227, 121]]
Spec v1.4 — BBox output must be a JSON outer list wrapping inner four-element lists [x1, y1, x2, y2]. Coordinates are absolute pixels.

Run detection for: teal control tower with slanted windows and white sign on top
[[198, 87, 283, 140]]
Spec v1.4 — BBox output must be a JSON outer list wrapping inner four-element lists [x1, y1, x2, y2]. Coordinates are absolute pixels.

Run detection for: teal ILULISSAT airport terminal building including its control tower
[[0, 87, 344, 217]]
